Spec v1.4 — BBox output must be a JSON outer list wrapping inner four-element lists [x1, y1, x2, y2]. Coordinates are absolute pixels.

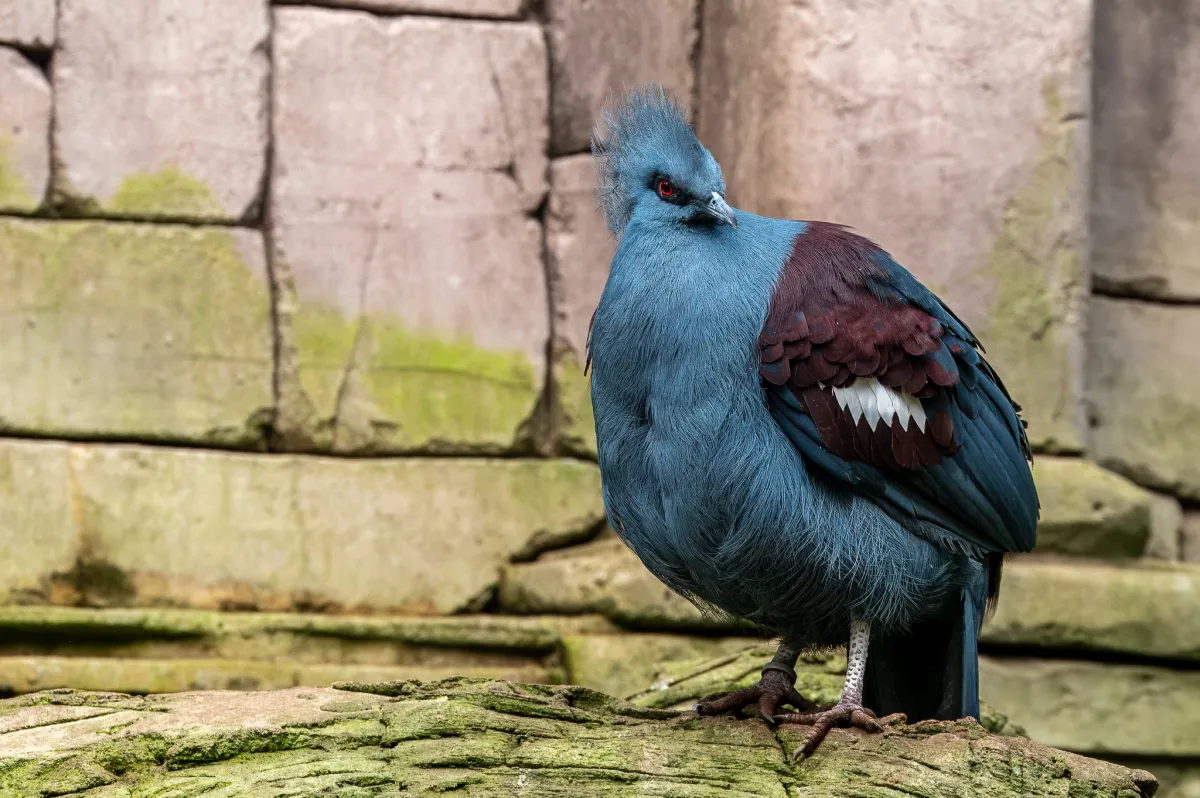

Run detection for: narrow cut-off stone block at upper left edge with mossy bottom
[[0, 47, 50, 211]]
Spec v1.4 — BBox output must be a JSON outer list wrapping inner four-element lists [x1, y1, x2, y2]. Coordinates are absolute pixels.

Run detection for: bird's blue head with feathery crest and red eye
[[592, 86, 738, 235]]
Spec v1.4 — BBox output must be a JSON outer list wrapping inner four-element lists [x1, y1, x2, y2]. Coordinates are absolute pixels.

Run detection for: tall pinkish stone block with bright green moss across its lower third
[[271, 8, 550, 452]]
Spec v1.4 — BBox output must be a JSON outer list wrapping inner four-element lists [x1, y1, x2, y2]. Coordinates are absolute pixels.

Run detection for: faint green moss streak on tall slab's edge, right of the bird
[[978, 79, 1085, 451]]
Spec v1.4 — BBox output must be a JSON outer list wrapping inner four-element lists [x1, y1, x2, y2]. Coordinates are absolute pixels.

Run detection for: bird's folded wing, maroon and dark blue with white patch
[[758, 222, 1038, 554]]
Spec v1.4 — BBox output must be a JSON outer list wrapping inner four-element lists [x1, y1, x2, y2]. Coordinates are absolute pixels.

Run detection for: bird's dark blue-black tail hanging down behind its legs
[[863, 559, 990, 724]]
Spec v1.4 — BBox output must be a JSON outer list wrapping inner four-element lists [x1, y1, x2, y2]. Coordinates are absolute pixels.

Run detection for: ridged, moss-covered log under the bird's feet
[[0, 678, 1157, 798]]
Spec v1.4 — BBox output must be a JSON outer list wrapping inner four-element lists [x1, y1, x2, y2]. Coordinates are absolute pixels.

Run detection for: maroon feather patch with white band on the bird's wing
[[758, 222, 960, 470]]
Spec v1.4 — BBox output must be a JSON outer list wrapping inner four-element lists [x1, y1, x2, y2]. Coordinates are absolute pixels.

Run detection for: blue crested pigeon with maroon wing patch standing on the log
[[588, 88, 1039, 755]]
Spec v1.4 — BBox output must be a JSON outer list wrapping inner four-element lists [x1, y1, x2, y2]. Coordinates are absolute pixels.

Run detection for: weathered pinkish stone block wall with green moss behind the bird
[[0, 0, 1200, 797]]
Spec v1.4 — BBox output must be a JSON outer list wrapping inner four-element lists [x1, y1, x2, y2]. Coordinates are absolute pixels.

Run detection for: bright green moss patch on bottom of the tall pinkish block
[[293, 300, 541, 451]]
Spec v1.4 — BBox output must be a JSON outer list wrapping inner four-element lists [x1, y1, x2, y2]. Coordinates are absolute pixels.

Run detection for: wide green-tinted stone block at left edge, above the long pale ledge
[[0, 218, 274, 446]]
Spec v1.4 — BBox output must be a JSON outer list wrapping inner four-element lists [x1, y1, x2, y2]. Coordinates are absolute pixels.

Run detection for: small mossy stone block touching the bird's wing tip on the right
[[1033, 457, 1153, 557]]
